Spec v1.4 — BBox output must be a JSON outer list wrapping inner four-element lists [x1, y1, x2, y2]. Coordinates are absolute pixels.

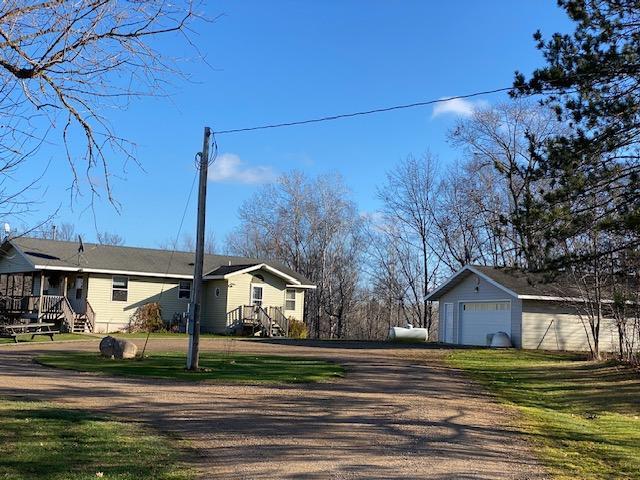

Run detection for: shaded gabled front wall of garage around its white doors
[[438, 274, 522, 347]]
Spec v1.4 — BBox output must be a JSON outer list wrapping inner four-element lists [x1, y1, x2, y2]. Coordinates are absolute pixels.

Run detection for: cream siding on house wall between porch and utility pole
[[87, 274, 189, 333]]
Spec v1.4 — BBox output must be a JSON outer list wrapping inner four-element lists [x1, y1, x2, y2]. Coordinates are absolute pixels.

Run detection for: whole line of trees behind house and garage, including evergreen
[[229, 0, 640, 360]]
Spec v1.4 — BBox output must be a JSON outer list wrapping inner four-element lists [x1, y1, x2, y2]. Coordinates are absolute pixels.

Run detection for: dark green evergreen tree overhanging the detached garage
[[512, 0, 640, 265]]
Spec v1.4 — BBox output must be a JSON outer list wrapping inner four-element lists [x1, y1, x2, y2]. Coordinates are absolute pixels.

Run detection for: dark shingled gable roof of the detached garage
[[427, 265, 581, 300]]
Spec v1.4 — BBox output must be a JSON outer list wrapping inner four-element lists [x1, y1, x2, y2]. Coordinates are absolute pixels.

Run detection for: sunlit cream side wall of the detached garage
[[522, 300, 618, 351]]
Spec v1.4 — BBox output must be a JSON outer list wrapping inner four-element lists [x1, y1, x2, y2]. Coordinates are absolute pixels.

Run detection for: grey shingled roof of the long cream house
[[8, 237, 312, 286]]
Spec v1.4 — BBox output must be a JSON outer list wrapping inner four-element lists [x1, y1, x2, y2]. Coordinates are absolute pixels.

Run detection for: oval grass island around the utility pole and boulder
[[36, 352, 344, 383]]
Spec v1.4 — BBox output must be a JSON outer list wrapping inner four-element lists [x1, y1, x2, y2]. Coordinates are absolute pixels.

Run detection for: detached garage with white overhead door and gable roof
[[428, 265, 617, 351]]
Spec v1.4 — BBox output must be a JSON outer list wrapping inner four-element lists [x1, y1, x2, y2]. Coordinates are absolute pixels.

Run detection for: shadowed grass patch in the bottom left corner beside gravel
[[0, 399, 193, 480]]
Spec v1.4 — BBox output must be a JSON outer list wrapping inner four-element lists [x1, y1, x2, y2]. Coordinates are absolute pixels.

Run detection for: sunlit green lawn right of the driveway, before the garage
[[449, 350, 640, 480]]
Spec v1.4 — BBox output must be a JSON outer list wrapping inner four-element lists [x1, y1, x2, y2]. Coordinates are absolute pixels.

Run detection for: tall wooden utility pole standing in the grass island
[[187, 127, 211, 371]]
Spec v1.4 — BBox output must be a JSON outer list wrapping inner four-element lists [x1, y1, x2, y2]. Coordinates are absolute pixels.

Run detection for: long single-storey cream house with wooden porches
[[0, 237, 315, 335]]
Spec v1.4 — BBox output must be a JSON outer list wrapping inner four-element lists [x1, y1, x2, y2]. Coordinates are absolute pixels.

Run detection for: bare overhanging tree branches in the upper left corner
[[0, 0, 196, 202]]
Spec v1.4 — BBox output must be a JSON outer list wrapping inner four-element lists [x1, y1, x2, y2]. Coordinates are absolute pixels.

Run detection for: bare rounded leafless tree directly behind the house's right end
[[228, 172, 362, 337]]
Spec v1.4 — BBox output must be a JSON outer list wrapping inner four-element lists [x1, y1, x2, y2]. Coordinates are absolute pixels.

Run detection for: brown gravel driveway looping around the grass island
[[0, 339, 546, 480]]
